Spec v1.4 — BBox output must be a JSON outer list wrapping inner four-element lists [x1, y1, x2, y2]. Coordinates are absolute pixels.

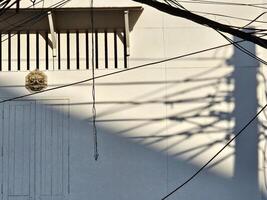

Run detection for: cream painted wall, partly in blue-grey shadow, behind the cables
[[0, 0, 267, 200]]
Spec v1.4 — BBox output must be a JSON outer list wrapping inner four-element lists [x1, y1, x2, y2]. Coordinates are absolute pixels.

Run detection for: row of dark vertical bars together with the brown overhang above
[[0, 7, 142, 71]]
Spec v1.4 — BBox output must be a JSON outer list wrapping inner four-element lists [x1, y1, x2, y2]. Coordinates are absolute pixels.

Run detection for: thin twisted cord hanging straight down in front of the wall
[[91, 0, 99, 161]]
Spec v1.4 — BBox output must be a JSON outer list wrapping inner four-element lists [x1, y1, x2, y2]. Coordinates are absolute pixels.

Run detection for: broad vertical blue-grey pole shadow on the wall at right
[[229, 35, 260, 199]]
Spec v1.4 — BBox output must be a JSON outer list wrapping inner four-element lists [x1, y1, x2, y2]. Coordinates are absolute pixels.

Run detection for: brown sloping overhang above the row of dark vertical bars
[[0, 7, 143, 33]]
